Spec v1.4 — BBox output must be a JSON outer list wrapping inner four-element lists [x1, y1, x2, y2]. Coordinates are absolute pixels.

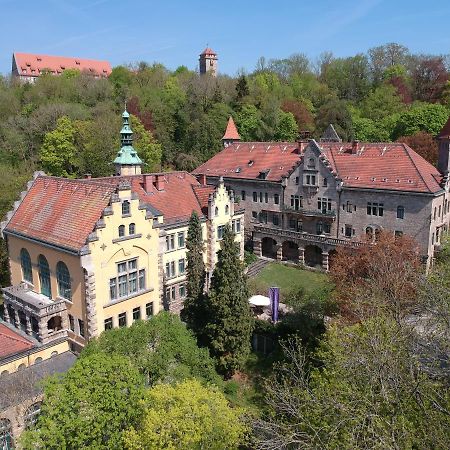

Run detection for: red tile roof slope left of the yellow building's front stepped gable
[[5, 176, 115, 251]]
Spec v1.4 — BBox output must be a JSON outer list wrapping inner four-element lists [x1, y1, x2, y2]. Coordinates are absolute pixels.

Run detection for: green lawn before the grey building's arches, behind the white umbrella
[[249, 263, 329, 300]]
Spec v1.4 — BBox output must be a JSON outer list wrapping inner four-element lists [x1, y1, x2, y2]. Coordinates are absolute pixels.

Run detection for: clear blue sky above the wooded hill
[[0, 0, 450, 75]]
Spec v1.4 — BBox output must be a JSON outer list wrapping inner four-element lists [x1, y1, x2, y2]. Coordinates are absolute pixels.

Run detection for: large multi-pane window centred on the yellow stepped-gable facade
[[109, 258, 145, 300]]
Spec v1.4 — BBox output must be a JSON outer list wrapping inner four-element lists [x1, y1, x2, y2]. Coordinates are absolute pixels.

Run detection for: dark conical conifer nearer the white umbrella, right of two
[[204, 225, 253, 377]]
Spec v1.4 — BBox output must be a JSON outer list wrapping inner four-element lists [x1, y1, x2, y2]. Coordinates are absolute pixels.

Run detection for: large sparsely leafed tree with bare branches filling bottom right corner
[[254, 317, 450, 450]]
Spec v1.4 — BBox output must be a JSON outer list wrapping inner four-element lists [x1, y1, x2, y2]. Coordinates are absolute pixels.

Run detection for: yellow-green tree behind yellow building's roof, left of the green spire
[[41, 116, 80, 177]]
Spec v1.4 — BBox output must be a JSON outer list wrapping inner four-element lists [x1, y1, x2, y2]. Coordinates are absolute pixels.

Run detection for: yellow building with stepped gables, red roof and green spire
[[0, 112, 244, 362]]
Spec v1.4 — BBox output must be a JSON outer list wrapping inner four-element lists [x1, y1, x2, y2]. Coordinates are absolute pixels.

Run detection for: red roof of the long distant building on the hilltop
[[13, 52, 111, 77]]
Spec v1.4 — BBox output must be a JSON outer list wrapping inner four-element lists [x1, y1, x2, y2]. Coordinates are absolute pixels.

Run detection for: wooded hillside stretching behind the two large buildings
[[0, 43, 450, 284]]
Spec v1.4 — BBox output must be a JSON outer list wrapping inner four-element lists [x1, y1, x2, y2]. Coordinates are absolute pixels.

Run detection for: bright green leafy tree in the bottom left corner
[[22, 354, 144, 450]]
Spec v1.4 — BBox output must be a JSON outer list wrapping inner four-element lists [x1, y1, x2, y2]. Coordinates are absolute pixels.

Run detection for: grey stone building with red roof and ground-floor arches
[[193, 118, 450, 270]]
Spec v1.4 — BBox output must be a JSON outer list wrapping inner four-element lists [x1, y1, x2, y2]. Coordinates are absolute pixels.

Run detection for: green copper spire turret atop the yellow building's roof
[[114, 109, 143, 176]]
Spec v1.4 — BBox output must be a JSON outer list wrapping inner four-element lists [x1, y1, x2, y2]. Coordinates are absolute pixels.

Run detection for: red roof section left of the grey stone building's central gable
[[192, 142, 300, 181]]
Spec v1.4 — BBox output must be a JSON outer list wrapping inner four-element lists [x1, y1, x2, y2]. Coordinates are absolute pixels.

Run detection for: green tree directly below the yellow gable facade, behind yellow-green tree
[[81, 312, 221, 385]]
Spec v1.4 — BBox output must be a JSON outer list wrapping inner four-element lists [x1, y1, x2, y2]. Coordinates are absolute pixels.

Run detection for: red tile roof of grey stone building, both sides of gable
[[193, 141, 442, 193]]
